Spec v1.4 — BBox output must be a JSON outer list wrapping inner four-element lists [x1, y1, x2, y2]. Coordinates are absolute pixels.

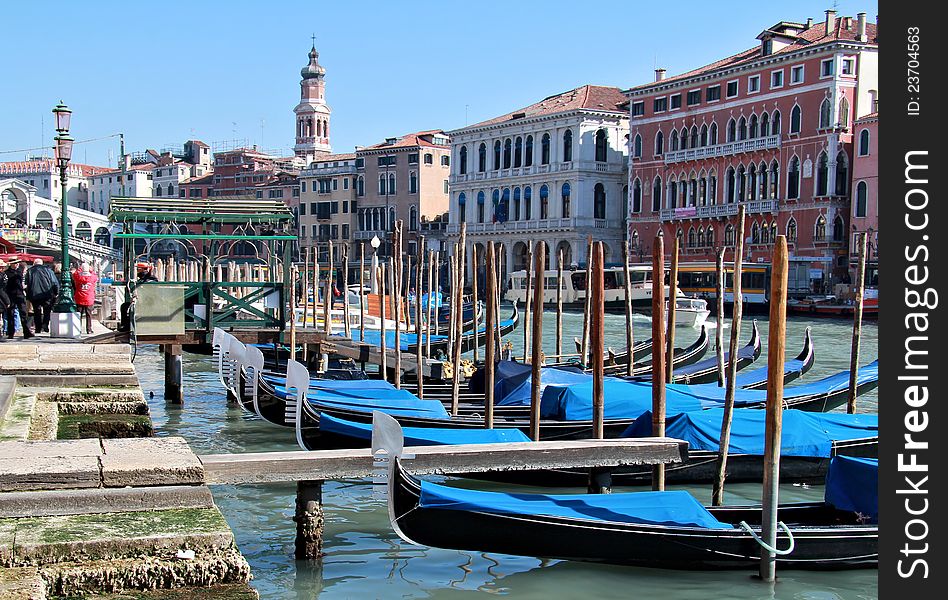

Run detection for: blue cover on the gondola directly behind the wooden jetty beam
[[319, 414, 530, 446]]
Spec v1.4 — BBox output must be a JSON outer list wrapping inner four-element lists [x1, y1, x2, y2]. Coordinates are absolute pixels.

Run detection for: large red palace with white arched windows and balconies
[[626, 10, 879, 293]]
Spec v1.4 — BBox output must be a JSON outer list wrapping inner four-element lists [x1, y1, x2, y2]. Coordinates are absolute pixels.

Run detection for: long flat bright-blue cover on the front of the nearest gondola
[[419, 481, 733, 529]]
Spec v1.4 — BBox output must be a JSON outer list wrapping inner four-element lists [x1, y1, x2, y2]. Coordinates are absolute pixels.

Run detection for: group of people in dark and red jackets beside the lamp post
[[0, 258, 99, 339]]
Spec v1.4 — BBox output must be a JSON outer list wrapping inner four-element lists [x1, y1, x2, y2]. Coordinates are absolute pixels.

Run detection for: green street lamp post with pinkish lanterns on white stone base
[[50, 101, 80, 338]]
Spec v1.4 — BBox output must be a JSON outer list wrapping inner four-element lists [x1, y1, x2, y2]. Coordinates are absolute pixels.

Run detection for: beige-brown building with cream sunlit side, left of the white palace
[[355, 129, 451, 256]]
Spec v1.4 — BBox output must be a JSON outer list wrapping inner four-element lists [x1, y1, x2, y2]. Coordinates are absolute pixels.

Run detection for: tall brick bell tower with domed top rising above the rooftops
[[293, 41, 332, 160]]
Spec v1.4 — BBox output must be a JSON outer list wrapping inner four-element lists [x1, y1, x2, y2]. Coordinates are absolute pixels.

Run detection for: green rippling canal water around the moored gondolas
[[135, 312, 878, 600]]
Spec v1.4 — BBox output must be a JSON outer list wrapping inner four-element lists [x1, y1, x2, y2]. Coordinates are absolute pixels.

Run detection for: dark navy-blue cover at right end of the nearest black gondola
[[824, 456, 879, 523]]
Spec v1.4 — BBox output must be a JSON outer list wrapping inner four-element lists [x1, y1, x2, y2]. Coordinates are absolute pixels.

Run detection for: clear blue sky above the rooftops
[[0, 0, 878, 165]]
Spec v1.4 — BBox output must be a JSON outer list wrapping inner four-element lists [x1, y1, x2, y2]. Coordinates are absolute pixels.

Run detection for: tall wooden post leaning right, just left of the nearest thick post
[[711, 204, 748, 506]]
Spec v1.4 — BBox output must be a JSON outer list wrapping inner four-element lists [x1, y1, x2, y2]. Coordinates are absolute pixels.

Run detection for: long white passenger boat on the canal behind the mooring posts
[[504, 265, 668, 308]]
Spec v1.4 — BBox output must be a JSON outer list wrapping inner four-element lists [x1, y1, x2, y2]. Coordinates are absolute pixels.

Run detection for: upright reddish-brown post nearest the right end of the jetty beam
[[652, 235, 665, 491]]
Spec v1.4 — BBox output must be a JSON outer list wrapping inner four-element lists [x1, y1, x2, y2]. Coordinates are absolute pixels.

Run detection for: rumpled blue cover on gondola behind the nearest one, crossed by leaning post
[[622, 408, 879, 458]]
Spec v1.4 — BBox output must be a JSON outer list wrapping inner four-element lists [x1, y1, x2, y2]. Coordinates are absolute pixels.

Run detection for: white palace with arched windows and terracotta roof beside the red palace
[[448, 85, 629, 276]]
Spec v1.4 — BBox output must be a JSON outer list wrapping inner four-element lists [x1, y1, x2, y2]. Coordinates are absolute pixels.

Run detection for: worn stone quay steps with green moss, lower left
[[0, 338, 257, 600]]
